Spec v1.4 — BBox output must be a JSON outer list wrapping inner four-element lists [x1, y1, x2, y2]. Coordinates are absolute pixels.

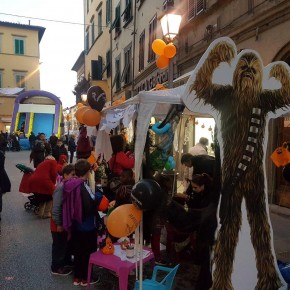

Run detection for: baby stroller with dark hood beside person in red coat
[[16, 163, 41, 214]]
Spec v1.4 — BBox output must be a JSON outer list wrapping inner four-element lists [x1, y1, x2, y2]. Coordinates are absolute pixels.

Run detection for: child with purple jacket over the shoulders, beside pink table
[[63, 159, 102, 286]]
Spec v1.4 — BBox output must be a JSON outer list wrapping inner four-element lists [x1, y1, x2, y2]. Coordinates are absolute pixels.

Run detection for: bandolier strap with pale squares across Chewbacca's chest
[[222, 108, 262, 189]]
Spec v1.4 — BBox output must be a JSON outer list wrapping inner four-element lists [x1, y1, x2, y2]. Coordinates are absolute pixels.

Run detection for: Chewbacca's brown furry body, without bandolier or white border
[[191, 42, 290, 290]]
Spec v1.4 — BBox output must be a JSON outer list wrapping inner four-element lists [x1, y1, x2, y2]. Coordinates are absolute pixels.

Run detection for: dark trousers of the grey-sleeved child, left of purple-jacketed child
[[51, 231, 72, 272]]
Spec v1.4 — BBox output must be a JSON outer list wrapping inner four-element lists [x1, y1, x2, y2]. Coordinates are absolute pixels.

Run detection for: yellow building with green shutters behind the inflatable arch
[[0, 21, 45, 131]]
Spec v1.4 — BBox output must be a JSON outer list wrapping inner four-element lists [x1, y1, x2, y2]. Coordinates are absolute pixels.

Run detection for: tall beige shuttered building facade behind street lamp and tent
[[75, 0, 290, 205]]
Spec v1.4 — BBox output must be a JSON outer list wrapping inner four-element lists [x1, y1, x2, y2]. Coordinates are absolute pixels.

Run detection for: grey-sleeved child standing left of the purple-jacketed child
[[50, 164, 75, 276]]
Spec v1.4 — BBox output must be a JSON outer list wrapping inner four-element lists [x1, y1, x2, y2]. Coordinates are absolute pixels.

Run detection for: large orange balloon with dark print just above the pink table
[[107, 204, 142, 238]]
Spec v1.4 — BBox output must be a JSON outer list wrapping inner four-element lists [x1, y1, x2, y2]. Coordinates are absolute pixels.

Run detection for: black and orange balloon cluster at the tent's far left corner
[[75, 86, 106, 126]]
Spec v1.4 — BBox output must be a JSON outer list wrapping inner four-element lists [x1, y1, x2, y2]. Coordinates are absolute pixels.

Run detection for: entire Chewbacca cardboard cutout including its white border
[[182, 37, 290, 290]]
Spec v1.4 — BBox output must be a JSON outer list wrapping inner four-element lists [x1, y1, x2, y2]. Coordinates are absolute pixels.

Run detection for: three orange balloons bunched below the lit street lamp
[[152, 39, 176, 69]]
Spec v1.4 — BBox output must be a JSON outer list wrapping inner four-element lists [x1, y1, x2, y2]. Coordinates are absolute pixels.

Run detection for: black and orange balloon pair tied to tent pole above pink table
[[107, 179, 164, 238]]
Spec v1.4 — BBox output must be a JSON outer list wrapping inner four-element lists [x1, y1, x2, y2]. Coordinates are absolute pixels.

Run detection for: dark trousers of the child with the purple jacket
[[73, 230, 97, 280]]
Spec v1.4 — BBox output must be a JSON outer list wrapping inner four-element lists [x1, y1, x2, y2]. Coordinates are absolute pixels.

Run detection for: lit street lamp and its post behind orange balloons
[[160, 11, 181, 88]]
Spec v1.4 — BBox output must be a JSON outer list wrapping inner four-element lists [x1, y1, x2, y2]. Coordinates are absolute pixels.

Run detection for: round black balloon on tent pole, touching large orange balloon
[[131, 179, 164, 210]]
